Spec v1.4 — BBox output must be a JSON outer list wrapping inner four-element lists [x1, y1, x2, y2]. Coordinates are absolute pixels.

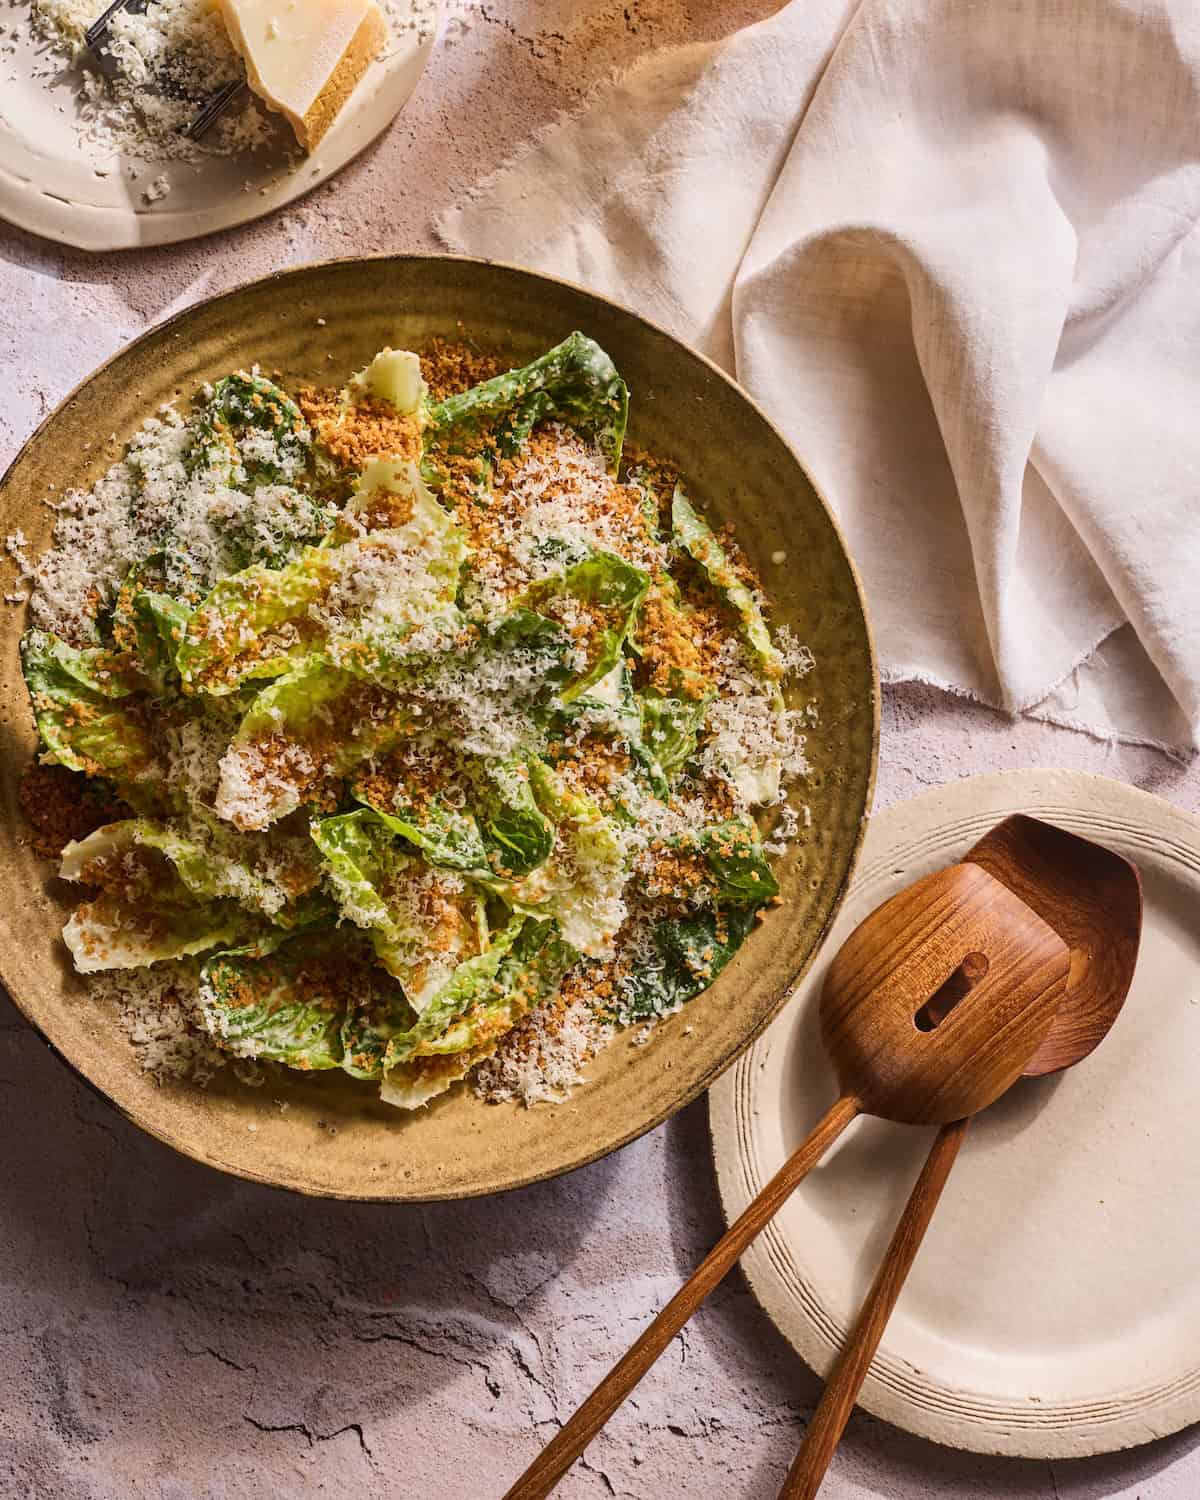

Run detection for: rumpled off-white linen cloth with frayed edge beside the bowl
[[440, 0, 1200, 749]]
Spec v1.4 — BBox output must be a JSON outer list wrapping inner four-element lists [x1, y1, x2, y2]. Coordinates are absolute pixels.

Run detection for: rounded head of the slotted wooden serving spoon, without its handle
[[821, 864, 1070, 1125]]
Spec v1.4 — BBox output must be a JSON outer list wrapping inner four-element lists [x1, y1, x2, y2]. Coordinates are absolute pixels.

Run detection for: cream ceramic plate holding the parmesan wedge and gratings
[[0, 0, 440, 251]]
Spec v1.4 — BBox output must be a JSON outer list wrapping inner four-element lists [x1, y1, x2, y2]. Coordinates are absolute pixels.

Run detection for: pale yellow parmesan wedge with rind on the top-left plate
[[221, 0, 387, 152]]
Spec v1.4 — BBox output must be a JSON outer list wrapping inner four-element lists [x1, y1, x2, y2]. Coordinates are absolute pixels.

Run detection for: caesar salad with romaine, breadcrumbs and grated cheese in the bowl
[[9, 333, 815, 1109]]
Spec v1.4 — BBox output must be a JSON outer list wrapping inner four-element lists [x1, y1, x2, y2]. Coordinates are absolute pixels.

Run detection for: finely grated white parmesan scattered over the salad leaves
[[6, 343, 816, 1106]]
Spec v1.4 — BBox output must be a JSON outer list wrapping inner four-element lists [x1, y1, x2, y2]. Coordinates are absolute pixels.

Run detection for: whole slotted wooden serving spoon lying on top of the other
[[506, 864, 1070, 1500]]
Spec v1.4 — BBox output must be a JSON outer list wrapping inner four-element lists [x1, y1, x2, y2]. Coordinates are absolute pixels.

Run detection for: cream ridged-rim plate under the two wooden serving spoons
[[710, 771, 1200, 1458]]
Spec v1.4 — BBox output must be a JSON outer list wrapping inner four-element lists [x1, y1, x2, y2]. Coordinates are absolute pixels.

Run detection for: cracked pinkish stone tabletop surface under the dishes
[[0, 0, 1200, 1500]]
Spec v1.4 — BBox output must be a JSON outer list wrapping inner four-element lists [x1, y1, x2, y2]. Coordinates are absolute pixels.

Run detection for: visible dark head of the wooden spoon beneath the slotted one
[[966, 813, 1142, 1079]]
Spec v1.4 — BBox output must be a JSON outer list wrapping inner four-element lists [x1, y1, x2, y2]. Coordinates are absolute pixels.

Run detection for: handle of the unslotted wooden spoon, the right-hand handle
[[779, 1121, 968, 1500]]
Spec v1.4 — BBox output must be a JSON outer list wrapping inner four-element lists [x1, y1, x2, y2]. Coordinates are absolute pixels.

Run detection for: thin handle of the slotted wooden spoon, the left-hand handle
[[504, 1098, 858, 1500]]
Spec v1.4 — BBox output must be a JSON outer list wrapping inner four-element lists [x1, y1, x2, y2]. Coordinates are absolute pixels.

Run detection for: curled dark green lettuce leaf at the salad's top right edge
[[429, 333, 629, 474]]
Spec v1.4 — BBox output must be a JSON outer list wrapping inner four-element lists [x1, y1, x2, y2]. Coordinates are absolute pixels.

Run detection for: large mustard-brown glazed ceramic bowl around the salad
[[0, 257, 879, 1202]]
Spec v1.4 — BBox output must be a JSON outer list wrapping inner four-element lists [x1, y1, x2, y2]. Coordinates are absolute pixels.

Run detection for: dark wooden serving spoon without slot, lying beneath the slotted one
[[780, 816, 1142, 1500]]
